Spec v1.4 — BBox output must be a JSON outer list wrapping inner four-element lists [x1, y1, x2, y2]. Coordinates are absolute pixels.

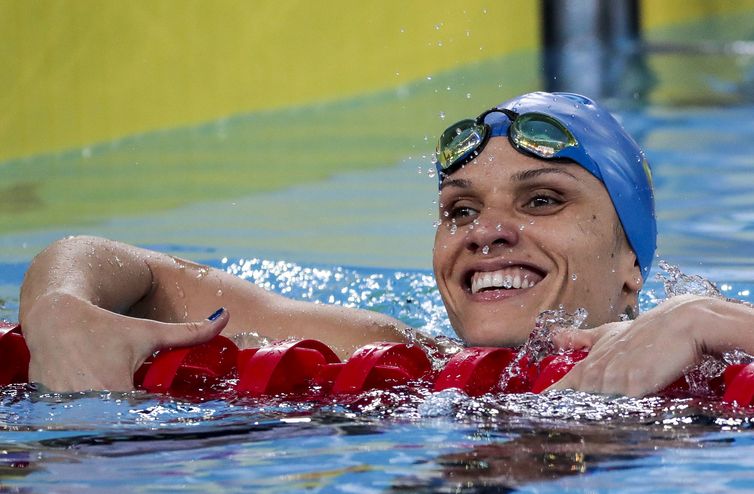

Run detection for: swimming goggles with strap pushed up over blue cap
[[436, 108, 602, 181]]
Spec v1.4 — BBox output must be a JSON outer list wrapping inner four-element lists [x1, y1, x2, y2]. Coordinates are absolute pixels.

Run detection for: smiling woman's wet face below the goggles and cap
[[433, 137, 642, 346]]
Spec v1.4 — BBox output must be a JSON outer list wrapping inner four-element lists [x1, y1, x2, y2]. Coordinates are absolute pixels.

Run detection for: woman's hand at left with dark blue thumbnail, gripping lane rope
[[22, 293, 230, 391]]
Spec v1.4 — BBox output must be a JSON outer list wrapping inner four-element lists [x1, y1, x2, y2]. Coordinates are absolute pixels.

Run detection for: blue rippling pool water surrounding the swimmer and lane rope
[[7, 54, 754, 492]]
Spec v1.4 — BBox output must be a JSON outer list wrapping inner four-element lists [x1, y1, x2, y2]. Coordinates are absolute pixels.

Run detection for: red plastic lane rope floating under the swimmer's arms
[[0, 322, 754, 406]]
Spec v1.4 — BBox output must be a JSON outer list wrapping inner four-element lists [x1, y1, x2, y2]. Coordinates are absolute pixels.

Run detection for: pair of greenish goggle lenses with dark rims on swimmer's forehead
[[437, 109, 578, 174]]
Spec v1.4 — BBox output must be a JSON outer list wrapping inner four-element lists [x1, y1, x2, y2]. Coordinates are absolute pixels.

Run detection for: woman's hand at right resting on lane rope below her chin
[[548, 295, 732, 396]]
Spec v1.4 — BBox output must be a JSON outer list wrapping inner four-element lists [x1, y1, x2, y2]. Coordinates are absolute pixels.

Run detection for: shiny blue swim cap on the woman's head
[[485, 92, 657, 280]]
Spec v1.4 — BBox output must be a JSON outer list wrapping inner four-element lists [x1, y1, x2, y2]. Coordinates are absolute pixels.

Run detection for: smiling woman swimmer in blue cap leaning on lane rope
[[19, 93, 754, 396]]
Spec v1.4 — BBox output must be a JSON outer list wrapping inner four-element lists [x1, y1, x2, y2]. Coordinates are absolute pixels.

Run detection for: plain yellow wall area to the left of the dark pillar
[[0, 0, 539, 161]]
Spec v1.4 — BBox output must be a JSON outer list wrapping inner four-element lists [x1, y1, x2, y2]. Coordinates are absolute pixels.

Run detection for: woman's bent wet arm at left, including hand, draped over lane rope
[[19, 237, 412, 391]]
